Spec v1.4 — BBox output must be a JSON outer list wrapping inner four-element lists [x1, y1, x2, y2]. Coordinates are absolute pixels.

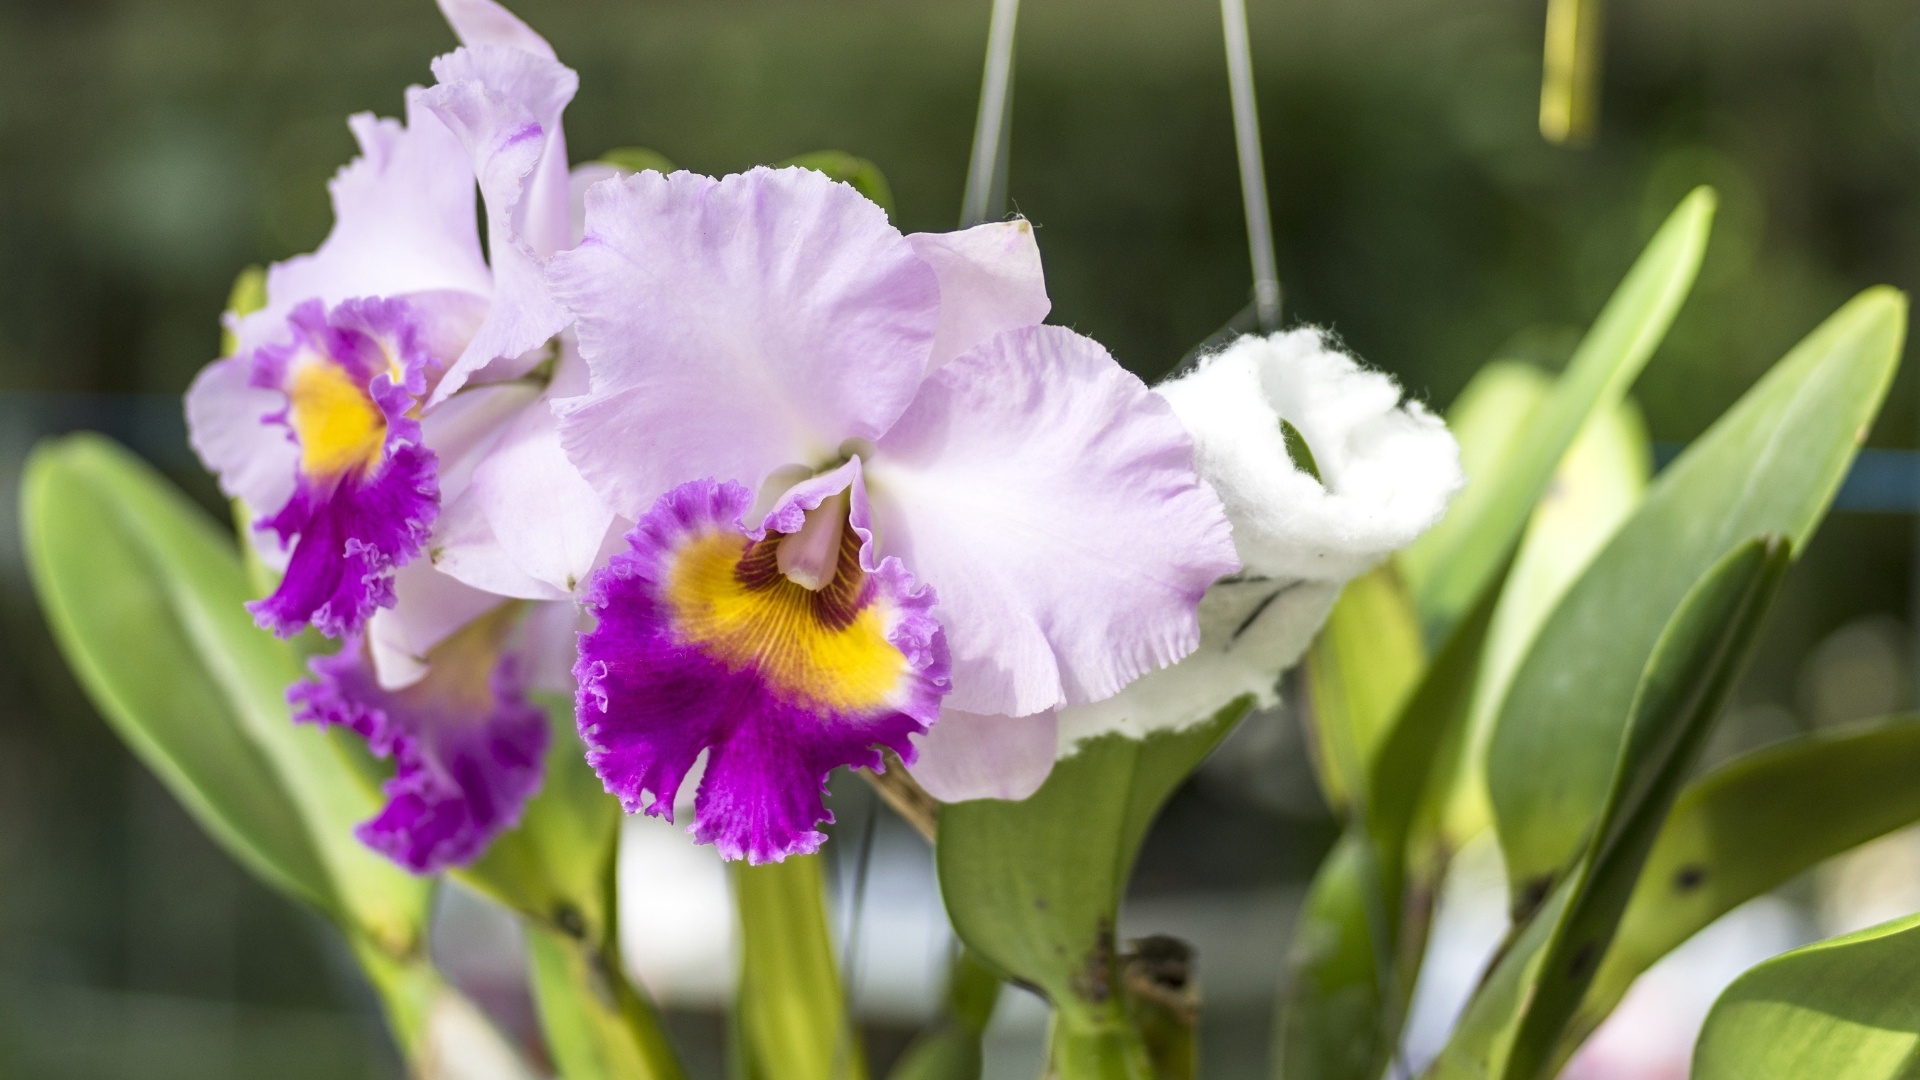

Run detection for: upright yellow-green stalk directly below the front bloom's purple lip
[[732, 855, 866, 1080]]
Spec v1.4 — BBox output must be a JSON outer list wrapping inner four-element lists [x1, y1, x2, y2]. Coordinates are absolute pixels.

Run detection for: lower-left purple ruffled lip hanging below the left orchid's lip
[[286, 609, 549, 874]]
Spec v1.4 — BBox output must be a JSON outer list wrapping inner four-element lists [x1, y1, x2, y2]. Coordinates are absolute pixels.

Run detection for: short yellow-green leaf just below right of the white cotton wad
[[1308, 563, 1427, 807]]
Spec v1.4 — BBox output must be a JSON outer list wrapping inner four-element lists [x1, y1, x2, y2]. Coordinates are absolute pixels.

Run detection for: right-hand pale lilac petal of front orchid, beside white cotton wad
[[868, 327, 1238, 717]]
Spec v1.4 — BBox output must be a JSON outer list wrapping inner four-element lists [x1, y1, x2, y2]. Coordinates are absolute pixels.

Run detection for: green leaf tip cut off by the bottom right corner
[[1693, 915, 1920, 1080]]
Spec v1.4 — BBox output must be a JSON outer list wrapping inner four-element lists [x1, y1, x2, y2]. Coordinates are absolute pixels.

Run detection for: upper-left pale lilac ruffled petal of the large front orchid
[[549, 169, 939, 519]]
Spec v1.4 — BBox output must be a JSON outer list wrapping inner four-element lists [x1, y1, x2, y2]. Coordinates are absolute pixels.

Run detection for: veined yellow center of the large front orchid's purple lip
[[666, 515, 906, 713]]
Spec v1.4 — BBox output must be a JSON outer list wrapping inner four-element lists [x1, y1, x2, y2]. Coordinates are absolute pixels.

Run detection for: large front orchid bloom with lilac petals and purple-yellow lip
[[549, 169, 1238, 863]]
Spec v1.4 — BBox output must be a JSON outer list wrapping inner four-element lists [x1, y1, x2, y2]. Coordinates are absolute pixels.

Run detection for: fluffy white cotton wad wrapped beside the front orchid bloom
[[1058, 327, 1467, 755]]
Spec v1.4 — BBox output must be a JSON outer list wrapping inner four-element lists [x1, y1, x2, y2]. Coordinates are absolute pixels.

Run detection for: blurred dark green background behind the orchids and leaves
[[0, 0, 1920, 1080]]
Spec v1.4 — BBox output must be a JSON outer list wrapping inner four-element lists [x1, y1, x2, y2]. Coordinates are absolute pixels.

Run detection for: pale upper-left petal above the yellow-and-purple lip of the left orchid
[[234, 88, 493, 354]]
